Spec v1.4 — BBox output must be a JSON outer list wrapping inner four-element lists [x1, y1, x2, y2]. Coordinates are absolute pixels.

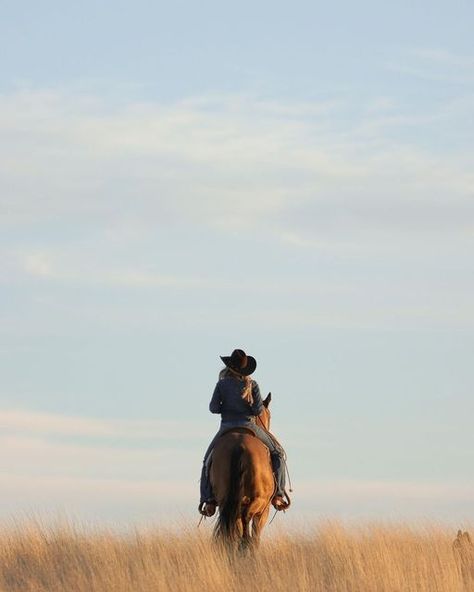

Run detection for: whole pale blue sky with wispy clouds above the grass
[[0, 1, 474, 525]]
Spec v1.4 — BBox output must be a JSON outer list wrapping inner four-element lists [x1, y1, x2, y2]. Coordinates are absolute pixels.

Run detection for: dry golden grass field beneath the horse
[[0, 523, 474, 592]]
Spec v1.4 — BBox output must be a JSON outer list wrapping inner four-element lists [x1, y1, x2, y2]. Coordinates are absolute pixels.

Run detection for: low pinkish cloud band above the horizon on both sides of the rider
[[0, 410, 474, 524]]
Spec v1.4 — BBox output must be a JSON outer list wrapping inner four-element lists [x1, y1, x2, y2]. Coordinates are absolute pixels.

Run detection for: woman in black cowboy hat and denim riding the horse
[[199, 349, 289, 516]]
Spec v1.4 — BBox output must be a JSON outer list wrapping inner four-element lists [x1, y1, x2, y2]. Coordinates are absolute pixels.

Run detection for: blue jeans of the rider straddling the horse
[[201, 420, 285, 502]]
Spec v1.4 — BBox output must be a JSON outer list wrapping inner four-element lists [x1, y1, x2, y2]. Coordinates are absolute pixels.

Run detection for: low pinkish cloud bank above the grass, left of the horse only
[[0, 409, 204, 524]]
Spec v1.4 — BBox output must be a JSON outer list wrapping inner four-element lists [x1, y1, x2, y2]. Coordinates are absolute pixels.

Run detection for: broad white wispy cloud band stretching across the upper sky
[[0, 87, 473, 240]]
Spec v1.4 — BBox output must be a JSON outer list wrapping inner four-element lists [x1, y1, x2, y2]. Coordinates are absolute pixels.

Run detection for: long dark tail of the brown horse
[[214, 445, 244, 540]]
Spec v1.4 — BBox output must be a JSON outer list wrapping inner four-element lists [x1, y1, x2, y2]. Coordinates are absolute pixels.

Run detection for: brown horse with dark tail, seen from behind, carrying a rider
[[210, 393, 275, 550]]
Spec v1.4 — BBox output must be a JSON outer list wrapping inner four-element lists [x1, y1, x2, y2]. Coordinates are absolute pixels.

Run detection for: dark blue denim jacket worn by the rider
[[209, 377, 263, 423]]
